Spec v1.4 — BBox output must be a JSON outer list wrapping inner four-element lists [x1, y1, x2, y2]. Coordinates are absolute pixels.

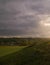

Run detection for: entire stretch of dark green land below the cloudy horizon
[[0, 38, 50, 65]]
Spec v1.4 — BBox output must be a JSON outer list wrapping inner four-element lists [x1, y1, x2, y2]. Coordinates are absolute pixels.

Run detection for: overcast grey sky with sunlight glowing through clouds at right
[[0, 0, 50, 37]]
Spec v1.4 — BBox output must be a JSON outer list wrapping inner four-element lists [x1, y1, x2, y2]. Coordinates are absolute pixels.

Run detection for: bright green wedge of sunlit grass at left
[[0, 46, 24, 57]]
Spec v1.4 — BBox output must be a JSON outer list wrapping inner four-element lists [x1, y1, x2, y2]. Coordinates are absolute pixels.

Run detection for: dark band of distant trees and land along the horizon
[[0, 38, 48, 46]]
